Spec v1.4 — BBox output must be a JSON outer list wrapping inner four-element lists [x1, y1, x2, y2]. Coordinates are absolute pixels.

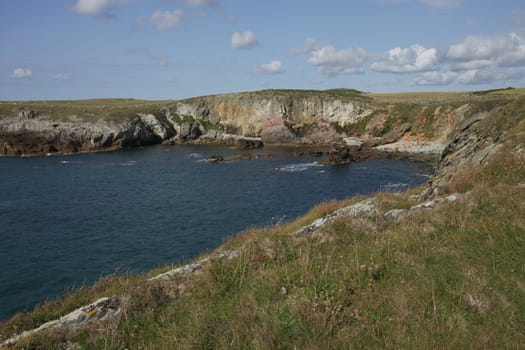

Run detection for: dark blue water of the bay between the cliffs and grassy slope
[[0, 146, 431, 319]]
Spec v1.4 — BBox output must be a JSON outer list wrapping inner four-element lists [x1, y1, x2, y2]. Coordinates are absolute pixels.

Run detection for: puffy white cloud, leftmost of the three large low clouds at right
[[308, 45, 368, 76]]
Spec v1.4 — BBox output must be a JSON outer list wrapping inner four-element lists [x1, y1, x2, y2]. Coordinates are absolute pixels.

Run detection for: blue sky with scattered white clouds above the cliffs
[[0, 0, 525, 100]]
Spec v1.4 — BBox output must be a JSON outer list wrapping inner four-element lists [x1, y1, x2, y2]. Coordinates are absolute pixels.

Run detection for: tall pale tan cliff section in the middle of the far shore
[[174, 92, 373, 136]]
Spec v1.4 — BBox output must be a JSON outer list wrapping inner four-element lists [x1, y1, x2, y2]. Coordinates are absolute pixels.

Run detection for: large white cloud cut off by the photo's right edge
[[446, 33, 525, 69]]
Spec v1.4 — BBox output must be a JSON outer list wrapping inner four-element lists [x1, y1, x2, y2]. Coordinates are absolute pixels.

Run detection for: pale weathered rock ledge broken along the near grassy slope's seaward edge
[[0, 91, 523, 349]]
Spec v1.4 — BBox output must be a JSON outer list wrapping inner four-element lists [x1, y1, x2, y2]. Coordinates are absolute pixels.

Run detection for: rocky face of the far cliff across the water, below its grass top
[[0, 91, 463, 156]]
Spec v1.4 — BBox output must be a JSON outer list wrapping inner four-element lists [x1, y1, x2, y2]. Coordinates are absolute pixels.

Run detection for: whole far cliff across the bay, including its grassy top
[[0, 90, 512, 157]]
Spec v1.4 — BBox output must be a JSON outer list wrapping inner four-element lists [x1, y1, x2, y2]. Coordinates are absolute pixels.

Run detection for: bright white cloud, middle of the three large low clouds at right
[[372, 45, 438, 73]]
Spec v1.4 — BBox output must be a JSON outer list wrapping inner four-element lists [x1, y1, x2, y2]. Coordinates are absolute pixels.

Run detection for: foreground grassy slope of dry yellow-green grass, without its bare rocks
[[0, 90, 525, 349]]
